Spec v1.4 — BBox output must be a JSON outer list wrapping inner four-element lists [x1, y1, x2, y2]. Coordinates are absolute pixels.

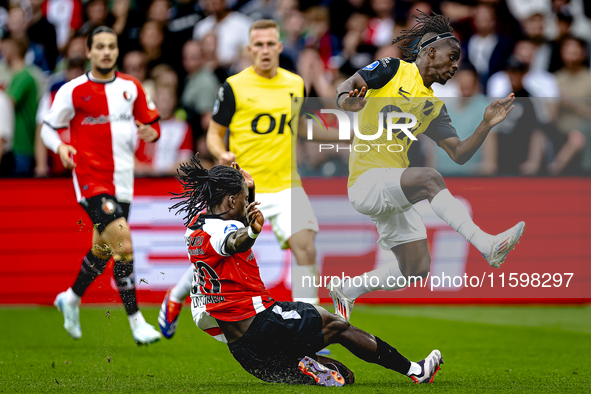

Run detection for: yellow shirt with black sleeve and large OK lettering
[[213, 66, 304, 193]]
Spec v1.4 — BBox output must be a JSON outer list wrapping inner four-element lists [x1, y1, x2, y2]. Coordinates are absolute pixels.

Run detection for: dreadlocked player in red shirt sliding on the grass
[[171, 156, 443, 386]]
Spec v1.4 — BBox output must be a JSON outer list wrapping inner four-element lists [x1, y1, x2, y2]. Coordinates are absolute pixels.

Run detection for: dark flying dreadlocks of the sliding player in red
[[169, 154, 244, 226]]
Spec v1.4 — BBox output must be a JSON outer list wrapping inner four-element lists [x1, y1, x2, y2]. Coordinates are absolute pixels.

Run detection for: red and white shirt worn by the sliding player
[[185, 214, 275, 342]]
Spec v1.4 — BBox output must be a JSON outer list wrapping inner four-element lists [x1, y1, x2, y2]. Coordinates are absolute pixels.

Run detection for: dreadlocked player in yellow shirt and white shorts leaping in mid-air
[[329, 13, 525, 320]]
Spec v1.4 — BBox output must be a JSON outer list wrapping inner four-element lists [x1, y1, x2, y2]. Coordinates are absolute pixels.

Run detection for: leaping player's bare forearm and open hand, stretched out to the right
[[439, 93, 515, 164]]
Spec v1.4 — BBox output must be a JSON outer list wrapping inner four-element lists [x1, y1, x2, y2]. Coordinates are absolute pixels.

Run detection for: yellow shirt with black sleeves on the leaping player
[[348, 58, 457, 187]]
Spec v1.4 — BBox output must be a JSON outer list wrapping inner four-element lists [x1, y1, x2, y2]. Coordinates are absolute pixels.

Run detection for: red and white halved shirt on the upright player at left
[[42, 72, 160, 202]]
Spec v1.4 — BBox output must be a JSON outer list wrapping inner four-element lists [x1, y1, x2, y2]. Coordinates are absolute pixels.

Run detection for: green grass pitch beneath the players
[[0, 306, 591, 393]]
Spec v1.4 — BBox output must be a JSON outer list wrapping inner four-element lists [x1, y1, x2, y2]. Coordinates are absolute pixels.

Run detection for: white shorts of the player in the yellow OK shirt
[[255, 187, 318, 249]]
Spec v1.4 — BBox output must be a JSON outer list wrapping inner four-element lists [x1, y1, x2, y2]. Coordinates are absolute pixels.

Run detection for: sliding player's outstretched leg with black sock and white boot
[[316, 306, 443, 383]]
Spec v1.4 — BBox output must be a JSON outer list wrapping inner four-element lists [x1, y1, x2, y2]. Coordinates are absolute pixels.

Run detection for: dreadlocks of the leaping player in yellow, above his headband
[[392, 10, 453, 62]]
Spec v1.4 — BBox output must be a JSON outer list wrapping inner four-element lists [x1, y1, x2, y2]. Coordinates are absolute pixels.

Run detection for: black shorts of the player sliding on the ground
[[228, 302, 325, 384]]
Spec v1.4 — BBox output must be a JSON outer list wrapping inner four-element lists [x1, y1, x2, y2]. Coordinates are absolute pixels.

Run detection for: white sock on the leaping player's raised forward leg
[[431, 189, 494, 255]]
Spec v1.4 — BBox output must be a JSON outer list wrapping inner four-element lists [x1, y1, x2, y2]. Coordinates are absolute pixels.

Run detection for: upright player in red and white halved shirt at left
[[41, 26, 161, 343]]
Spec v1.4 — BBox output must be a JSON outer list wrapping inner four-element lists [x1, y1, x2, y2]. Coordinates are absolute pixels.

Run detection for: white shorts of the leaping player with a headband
[[348, 168, 427, 250]]
